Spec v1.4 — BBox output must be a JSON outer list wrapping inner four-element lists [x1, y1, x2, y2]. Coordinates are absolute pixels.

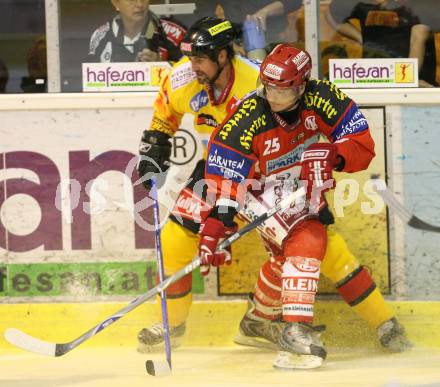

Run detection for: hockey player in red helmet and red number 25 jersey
[[199, 44, 374, 368]]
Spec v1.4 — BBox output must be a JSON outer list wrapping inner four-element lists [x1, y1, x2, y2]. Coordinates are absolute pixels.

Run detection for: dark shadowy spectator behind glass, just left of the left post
[[20, 36, 47, 93]]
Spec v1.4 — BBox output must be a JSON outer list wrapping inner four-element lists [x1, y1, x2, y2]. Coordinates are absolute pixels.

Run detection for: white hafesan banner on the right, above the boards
[[329, 58, 419, 88]]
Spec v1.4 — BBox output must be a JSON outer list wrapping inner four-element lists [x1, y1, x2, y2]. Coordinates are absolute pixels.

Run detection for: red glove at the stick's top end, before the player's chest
[[301, 143, 338, 206]]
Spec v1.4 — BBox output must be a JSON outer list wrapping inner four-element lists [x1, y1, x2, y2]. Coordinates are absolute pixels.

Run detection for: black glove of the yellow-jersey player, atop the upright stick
[[138, 130, 171, 190]]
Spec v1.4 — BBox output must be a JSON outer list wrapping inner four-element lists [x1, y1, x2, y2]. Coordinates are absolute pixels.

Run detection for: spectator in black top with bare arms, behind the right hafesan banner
[[327, 0, 434, 86]]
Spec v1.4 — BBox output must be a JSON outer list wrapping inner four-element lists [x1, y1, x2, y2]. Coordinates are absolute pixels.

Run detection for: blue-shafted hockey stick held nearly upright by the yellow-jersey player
[[145, 177, 171, 376]]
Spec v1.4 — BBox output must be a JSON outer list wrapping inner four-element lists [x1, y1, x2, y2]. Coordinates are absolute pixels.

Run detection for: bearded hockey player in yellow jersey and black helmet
[[138, 17, 409, 352]]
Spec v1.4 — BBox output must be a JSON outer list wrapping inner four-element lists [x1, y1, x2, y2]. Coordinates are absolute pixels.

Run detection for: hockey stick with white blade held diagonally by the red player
[[4, 188, 305, 357]]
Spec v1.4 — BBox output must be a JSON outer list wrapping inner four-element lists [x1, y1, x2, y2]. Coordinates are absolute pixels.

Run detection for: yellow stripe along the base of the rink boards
[[0, 300, 440, 349]]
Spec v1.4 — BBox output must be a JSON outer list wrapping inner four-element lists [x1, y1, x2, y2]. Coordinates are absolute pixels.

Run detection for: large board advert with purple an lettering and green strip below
[[0, 108, 203, 300]]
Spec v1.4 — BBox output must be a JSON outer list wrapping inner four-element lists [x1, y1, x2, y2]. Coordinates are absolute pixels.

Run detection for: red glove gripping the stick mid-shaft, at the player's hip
[[199, 218, 238, 275]]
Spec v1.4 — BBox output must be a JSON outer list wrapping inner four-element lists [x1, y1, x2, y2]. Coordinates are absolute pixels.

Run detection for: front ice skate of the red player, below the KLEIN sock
[[273, 323, 327, 370]]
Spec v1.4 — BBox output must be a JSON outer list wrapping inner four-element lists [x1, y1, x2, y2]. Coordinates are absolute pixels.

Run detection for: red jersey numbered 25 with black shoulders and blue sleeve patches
[[205, 80, 374, 239]]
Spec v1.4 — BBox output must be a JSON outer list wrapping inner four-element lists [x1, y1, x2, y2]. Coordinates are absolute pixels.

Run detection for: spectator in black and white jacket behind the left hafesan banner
[[88, 0, 186, 62]]
